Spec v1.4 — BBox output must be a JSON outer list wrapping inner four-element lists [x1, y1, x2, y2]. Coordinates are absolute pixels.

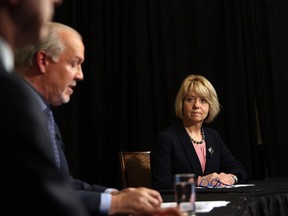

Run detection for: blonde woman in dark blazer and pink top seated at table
[[151, 75, 247, 190]]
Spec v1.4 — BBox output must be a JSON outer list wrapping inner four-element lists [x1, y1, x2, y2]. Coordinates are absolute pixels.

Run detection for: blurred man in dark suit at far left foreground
[[0, 0, 86, 216]]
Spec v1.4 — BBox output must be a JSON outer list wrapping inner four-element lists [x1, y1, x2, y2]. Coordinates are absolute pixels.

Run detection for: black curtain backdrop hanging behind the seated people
[[54, 0, 288, 188]]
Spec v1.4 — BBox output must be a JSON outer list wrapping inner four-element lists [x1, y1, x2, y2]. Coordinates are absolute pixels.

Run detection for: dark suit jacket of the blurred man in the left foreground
[[0, 61, 87, 216]]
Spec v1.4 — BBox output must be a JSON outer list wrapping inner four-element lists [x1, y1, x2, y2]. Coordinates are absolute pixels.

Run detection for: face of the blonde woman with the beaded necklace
[[182, 91, 210, 124]]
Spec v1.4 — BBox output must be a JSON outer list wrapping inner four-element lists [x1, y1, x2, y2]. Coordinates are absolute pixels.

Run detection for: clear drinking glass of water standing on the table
[[174, 173, 196, 215]]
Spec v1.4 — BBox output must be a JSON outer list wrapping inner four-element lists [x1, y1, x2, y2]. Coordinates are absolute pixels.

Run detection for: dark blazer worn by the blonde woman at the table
[[151, 122, 247, 190]]
